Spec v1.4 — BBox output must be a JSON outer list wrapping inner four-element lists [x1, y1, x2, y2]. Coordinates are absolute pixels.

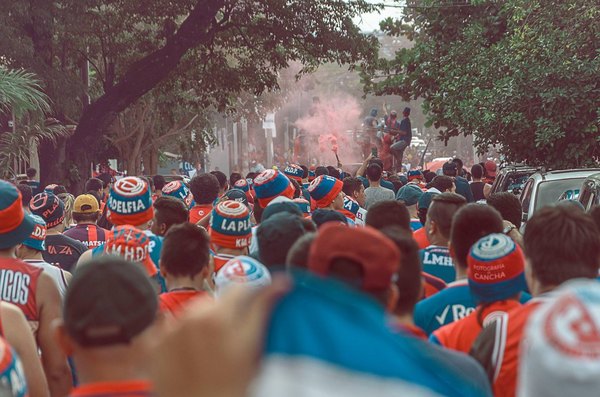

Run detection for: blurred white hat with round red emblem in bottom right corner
[[517, 279, 600, 397]]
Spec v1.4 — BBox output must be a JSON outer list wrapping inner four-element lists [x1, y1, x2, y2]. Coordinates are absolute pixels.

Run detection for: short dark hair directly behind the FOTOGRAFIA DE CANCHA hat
[[450, 203, 504, 268]]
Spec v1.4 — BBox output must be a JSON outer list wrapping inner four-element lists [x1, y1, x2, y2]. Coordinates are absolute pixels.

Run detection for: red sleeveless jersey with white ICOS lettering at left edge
[[0, 258, 44, 334]]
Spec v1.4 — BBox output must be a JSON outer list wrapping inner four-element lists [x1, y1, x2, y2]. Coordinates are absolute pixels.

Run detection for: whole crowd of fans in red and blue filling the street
[[0, 156, 600, 397]]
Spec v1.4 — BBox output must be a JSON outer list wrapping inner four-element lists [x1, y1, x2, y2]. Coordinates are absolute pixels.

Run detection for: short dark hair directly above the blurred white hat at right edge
[[523, 206, 600, 286]]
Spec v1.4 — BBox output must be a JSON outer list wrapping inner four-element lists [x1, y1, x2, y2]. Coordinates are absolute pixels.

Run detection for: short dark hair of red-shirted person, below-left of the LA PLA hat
[[160, 222, 210, 277]]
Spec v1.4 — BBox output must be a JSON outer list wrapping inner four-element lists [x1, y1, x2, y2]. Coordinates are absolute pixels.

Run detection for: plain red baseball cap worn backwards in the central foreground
[[308, 224, 400, 291]]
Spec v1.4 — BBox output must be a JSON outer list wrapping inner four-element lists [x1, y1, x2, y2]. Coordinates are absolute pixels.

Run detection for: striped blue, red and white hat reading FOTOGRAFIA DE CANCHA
[[467, 233, 527, 303]]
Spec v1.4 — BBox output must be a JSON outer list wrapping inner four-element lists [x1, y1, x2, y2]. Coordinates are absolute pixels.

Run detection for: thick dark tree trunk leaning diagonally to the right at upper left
[[62, 0, 224, 193]]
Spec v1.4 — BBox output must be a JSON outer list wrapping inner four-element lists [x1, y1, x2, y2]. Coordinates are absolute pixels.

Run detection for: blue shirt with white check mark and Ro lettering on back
[[413, 279, 531, 335]]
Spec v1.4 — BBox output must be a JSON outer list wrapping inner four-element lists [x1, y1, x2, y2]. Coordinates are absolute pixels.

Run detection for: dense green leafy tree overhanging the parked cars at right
[[363, 0, 600, 168]]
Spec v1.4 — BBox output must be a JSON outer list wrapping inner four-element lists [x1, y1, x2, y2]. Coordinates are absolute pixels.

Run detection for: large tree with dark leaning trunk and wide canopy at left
[[0, 0, 377, 192]]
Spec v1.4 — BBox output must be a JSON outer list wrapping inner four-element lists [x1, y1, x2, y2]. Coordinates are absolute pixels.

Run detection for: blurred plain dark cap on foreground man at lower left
[[63, 256, 158, 347]]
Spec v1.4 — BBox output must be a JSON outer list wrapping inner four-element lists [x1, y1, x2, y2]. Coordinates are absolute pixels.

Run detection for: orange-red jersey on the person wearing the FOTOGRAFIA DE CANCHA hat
[[429, 299, 521, 353]]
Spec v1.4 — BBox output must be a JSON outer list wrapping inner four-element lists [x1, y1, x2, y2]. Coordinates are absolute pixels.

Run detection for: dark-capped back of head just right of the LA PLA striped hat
[[256, 212, 305, 269]]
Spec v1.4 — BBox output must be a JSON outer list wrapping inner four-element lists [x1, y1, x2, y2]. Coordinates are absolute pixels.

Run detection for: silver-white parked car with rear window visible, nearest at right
[[520, 168, 600, 228]]
